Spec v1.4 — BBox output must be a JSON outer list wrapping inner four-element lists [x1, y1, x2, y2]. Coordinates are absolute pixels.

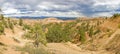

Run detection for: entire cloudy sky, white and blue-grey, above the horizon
[[0, 0, 120, 17]]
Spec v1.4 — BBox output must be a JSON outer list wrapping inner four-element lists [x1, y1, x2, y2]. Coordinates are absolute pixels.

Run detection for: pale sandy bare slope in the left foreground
[[1, 28, 27, 54]]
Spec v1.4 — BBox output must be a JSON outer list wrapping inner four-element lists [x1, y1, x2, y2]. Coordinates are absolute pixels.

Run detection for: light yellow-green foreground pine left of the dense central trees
[[25, 24, 47, 45]]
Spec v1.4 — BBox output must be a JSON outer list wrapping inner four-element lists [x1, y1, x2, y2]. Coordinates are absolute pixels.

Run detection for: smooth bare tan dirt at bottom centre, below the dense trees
[[47, 43, 97, 54]]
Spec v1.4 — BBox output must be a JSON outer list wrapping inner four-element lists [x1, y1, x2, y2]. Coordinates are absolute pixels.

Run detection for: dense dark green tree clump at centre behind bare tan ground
[[46, 23, 70, 42]]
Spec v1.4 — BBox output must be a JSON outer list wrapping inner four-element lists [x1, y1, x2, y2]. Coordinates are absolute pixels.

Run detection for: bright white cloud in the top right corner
[[93, 0, 120, 11]]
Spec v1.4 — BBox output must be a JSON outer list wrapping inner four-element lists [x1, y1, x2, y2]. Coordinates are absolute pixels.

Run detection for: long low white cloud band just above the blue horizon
[[6, 11, 84, 17]]
